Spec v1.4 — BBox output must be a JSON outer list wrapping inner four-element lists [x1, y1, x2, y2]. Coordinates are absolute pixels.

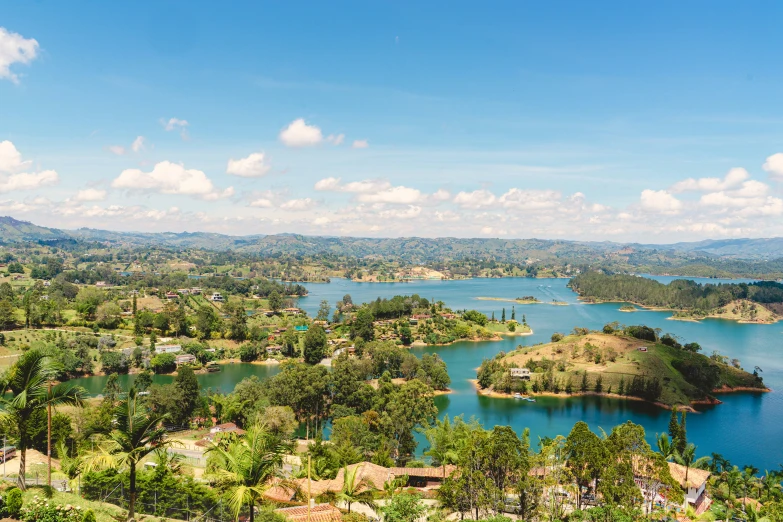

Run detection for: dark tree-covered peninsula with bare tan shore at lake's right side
[[569, 272, 783, 322]]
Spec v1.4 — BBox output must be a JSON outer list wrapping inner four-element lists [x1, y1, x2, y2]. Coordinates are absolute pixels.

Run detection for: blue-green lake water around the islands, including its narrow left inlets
[[70, 277, 783, 470]]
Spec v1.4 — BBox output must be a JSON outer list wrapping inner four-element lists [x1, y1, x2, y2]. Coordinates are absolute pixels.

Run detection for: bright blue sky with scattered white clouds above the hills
[[0, 2, 783, 242]]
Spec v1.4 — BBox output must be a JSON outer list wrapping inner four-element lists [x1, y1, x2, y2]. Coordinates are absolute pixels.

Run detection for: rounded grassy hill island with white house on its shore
[[477, 324, 769, 410]]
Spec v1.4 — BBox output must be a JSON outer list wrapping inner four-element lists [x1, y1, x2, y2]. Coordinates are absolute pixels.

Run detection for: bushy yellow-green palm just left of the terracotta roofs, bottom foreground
[[207, 424, 293, 522]]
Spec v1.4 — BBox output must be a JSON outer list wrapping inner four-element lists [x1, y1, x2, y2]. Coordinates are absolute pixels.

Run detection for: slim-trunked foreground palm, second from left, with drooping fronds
[[85, 388, 171, 520]]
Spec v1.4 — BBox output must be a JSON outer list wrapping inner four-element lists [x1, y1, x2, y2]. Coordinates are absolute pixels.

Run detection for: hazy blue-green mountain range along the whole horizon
[[0, 213, 783, 262]]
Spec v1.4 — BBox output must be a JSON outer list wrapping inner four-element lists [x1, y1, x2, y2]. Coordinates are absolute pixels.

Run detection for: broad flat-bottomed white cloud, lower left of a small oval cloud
[[112, 161, 234, 200]]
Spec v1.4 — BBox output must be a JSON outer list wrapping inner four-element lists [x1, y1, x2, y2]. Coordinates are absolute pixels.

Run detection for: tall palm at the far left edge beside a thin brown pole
[[0, 349, 87, 490]]
